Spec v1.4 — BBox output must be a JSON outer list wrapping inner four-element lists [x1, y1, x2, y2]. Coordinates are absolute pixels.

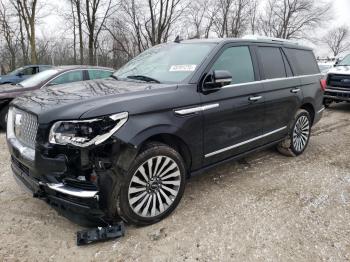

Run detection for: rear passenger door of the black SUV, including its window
[[257, 45, 303, 143]]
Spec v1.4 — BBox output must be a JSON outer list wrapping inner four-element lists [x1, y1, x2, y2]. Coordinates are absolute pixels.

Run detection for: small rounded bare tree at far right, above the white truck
[[322, 26, 350, 57]]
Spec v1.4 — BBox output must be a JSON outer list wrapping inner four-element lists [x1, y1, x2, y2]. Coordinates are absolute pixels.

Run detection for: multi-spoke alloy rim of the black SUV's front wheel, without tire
[[128, 156, 181, 218]]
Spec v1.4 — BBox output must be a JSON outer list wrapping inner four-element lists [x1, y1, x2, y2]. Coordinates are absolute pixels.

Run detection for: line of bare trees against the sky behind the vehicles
[[0, 0, 350, 71]]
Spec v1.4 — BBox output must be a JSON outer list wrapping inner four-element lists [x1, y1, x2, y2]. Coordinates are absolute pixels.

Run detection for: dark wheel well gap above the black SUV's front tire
[[142, 134, 192, 171]]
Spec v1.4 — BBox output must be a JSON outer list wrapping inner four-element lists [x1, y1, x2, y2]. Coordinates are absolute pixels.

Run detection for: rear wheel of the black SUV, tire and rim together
[[277, 109, 311, 157]]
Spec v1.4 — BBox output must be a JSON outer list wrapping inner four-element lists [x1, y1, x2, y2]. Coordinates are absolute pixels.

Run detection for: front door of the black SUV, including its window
[[201, 46, 264, 165]]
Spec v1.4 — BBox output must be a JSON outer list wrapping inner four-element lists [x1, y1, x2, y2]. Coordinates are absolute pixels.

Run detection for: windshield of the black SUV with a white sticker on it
[[114, 43, 215, 83]]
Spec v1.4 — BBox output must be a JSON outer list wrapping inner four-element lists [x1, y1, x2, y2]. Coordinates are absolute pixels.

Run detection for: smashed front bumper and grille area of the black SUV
[[7, 109, 137, 225]]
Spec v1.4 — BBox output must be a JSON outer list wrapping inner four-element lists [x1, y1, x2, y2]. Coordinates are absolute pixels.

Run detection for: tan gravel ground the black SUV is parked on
[[0, 104, 350, 261]]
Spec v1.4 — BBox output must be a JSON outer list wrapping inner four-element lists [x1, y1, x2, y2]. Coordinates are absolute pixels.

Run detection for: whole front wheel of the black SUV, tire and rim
[[117, 143, 186, 226]]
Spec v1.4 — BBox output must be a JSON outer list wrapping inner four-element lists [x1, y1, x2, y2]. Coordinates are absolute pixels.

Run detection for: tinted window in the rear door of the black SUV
[[258, 47, 287, 79]]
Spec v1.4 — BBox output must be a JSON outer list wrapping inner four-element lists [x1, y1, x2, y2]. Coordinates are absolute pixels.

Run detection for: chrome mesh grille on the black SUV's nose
[[13, 108, 38, 149]]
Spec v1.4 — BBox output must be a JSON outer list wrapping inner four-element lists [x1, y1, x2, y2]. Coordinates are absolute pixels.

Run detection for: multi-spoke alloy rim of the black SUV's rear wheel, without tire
[[293, 115, 310, 152]]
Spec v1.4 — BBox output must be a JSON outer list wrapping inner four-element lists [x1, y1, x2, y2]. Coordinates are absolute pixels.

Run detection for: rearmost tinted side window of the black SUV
[[287, 48, 320, 75]]
